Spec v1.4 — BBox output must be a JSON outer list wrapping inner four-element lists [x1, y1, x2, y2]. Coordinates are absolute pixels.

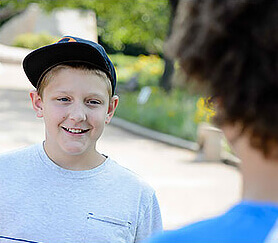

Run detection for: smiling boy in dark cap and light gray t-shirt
[[0, 36, 161, 243]]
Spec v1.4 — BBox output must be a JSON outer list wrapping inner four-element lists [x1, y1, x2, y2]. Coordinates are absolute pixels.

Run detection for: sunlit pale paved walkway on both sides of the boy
[[0, 63, 241, 229]]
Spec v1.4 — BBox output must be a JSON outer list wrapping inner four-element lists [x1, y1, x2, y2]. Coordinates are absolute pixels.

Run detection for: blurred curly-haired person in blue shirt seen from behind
[[146, 0, 278, 243]]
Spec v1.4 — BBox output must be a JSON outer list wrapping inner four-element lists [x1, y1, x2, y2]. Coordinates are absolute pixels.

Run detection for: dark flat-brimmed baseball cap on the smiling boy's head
[[23, 36, 117, 95]]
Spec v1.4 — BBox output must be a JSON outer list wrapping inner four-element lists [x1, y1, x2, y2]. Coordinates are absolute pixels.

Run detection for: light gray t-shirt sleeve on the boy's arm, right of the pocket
[[134, 193, 162, 243]]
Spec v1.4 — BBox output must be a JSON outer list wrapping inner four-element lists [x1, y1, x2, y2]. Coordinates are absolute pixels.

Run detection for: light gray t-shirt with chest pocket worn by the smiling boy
[[0, 144, 162, 243]]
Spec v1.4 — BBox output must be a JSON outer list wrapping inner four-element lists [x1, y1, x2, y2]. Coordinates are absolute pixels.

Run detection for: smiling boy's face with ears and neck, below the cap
[[31, 69, 118, 158]]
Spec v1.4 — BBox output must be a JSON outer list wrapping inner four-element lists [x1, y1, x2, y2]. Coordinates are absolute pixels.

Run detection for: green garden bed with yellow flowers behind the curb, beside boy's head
[[110, 54, 215, 141]]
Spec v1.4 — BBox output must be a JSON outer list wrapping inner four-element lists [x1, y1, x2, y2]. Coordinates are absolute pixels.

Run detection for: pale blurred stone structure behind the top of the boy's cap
[[0, 3, 97, 45]]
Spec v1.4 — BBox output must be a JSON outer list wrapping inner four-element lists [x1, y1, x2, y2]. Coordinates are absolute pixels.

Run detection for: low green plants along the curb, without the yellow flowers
[[116, 87, 198, 141]]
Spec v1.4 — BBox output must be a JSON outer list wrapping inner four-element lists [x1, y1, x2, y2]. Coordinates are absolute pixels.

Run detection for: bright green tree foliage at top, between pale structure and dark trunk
[[91, 0, 170, 53]]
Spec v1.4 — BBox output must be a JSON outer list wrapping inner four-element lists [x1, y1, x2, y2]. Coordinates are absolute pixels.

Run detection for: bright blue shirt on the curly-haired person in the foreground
[[144, 201, 278, 243]]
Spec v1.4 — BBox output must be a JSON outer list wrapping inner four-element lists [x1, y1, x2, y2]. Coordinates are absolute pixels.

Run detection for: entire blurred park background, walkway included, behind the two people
[[0, 0, 241, 229]]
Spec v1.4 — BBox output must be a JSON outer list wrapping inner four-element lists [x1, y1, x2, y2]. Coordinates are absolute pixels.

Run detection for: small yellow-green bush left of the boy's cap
[[13, 32, 58, 49]]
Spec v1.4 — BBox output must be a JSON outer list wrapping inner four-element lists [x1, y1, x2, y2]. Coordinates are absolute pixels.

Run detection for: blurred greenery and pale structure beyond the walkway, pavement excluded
[[0, 0, 217, 141]]
